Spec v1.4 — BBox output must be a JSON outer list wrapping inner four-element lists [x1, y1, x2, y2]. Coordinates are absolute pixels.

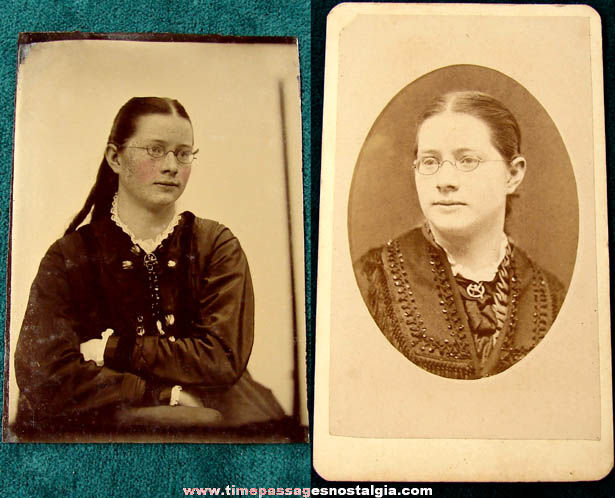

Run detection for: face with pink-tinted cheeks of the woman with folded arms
[[107, 114, 193, 210]]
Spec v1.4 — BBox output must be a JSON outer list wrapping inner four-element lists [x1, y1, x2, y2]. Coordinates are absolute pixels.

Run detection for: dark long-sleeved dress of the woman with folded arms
[[15, 212, 285, 438]]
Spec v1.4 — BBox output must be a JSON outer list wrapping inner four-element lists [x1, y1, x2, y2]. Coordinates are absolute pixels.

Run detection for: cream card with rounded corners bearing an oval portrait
[[314, 4, 613, 481]]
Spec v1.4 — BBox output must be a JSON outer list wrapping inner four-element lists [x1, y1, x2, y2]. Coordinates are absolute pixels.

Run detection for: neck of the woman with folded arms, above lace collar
[[117, 191, 175, 240]]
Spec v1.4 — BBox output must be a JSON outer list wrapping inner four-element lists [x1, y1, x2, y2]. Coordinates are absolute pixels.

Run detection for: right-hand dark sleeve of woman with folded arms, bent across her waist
[[105, 222, 254, 388]]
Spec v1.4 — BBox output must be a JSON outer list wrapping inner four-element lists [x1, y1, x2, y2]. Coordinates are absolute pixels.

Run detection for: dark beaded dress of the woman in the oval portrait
[[355, 228, 566, 379]]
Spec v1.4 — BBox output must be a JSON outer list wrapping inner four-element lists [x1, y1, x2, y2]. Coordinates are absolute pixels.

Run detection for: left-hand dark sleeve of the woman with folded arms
[[15, 242, 145, 416]]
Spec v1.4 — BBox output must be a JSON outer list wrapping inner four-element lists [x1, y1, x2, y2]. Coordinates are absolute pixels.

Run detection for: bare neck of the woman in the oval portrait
[[430, 224, 505, 272]]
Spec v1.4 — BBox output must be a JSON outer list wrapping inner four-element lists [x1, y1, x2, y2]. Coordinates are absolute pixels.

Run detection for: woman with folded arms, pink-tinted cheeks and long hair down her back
[[15, 97, 284, 431]]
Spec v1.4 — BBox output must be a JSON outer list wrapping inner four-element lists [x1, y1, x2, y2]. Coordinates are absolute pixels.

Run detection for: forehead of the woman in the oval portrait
[[417, 112, 494, 151]]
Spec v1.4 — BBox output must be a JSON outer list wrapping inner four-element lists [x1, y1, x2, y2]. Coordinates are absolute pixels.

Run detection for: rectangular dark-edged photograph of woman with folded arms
[[3, 33, 307, 442]]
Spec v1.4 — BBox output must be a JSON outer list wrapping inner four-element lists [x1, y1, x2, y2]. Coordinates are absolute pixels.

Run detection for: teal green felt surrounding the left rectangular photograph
[[0, 0, 312, 497]]
